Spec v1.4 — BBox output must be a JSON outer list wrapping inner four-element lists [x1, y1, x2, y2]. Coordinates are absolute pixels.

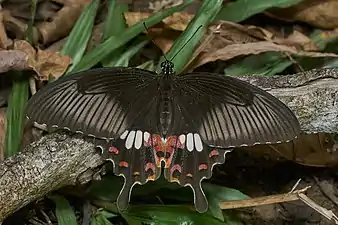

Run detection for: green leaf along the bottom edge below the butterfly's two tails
[[122, 205, 224, 225]]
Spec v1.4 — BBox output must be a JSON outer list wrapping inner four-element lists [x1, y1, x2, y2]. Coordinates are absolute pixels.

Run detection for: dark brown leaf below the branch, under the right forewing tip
[[241, 133, 338, 167]]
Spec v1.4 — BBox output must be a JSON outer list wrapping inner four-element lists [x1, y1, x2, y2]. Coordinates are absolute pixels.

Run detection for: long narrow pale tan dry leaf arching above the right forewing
[[190, 41, 338, 68]]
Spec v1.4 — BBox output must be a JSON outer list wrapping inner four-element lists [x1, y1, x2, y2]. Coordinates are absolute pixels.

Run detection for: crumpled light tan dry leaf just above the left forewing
[[14, 40, 71, 80]]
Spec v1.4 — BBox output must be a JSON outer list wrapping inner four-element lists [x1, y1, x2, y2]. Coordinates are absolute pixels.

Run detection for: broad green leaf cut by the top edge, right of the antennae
[[215, 0, 303, 22]]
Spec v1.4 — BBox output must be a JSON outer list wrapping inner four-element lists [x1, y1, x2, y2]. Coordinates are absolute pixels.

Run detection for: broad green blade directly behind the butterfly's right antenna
[[159, 0, 223, 73]]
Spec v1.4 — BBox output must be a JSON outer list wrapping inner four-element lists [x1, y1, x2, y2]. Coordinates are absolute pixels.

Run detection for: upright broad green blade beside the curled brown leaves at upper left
[[61, 0, 100, 74]]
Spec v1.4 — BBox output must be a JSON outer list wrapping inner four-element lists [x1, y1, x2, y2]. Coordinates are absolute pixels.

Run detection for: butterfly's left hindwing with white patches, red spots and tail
[[95, 133, 164, 210]]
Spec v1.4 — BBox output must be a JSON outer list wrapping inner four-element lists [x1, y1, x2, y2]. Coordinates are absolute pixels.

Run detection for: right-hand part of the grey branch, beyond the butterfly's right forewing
[[240, 68, 338, 133]]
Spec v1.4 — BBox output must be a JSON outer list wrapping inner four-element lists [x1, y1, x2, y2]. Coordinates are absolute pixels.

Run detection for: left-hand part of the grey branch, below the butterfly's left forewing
[[0, 132, 103, 221]]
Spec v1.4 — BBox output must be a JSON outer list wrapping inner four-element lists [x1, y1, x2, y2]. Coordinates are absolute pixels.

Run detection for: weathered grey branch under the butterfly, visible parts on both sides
[[0, 69, 338, 222]]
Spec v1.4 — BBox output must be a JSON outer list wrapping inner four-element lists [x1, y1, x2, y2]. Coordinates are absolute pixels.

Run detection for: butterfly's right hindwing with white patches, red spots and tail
[[164, 133, 230, 212]]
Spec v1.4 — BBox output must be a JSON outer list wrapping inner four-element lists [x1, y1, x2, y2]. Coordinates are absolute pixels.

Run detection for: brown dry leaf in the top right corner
[[267, 0, 338, 29]]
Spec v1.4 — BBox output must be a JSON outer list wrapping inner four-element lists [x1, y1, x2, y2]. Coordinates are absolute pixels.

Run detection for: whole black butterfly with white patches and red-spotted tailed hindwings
[[27, 60, 300, 212]]
